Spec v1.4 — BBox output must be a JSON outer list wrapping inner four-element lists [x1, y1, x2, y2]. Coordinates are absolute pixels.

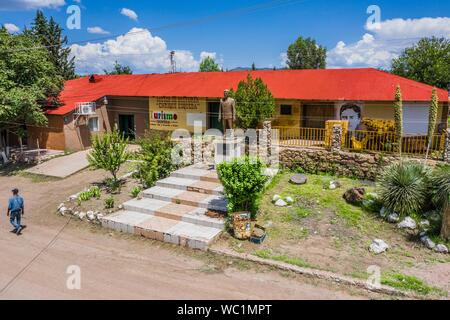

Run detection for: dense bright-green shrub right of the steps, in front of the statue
[[217, 157, 268, 218]]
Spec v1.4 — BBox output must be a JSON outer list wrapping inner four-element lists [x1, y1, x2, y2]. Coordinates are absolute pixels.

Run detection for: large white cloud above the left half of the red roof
[[71, 28, 216, 74]]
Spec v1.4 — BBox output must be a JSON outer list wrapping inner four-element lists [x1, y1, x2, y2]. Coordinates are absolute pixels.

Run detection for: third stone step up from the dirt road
[[143, 186, 227, 212]]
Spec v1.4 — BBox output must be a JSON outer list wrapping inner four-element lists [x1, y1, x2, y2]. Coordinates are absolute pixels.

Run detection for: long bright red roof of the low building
[[47, 69, 448, 115]]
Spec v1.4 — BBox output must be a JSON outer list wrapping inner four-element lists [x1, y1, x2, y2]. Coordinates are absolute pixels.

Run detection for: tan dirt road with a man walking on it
[[0, 170, 367, 299]]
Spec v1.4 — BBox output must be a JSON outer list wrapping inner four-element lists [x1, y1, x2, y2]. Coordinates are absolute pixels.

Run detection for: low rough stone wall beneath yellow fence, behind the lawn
[[280, 148, 398, 180]]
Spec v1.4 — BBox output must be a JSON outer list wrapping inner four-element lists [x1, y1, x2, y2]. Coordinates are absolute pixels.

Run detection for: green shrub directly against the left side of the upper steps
[[137, 132, 176, 188]]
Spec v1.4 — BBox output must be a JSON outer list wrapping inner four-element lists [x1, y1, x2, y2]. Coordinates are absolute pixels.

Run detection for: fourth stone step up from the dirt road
[[156, 176, 223, 195]]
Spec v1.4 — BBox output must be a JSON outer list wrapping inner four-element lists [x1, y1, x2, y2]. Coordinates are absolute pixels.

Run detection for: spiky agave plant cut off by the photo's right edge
[[430, 165, 450, 210]]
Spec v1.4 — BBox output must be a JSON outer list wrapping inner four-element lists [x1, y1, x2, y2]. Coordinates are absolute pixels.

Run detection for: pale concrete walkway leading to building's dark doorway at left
[[26, 150, 89, 178]]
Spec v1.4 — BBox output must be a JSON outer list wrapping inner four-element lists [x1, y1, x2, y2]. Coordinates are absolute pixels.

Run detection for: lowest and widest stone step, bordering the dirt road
[[101, 210, 222, 250]]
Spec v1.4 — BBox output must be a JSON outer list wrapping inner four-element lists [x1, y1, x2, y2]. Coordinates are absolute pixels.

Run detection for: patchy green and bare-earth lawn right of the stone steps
[[217, 172, 450, 294]]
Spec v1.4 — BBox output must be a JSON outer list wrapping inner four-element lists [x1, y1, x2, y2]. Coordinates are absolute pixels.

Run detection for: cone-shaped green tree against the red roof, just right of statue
[[232, 74, 275, 129]]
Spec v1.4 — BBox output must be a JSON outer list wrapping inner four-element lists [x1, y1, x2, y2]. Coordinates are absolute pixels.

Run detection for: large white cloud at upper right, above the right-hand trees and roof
[[327, 17, 450, 68]]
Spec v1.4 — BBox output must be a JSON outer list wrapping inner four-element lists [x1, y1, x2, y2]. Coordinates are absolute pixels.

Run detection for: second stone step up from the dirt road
[[123, 198, 225, 229]]
